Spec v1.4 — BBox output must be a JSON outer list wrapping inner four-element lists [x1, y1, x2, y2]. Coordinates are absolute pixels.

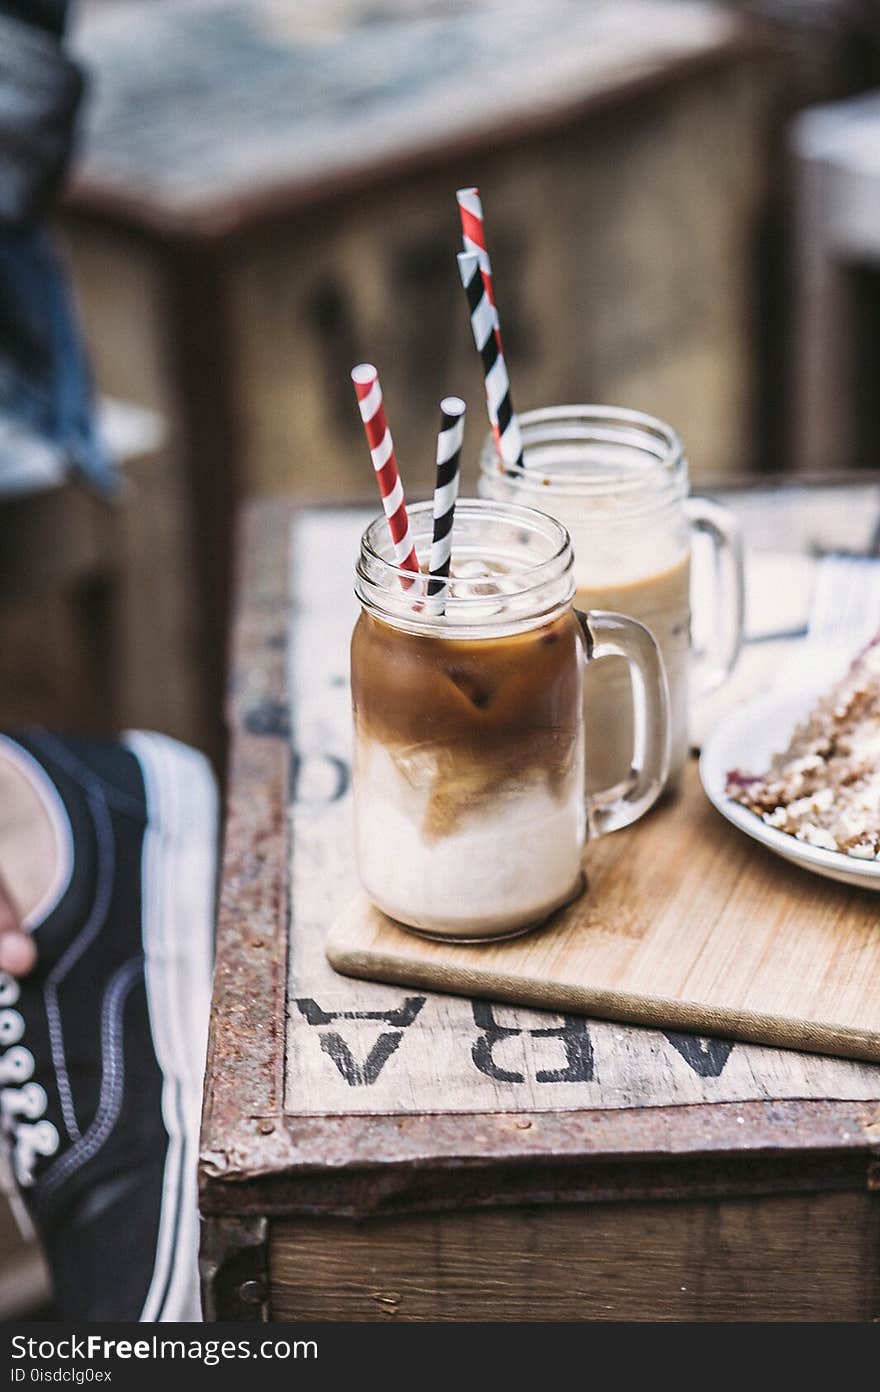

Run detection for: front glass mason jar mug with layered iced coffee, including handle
[[351, 498, 668, 941]]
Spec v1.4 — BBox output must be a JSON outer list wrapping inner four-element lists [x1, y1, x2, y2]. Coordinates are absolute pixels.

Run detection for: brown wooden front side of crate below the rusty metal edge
[[269, 1193, 880, 1322]]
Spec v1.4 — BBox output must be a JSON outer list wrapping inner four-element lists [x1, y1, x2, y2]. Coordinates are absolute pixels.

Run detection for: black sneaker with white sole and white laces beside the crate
[[0, 732, 217, 1321]]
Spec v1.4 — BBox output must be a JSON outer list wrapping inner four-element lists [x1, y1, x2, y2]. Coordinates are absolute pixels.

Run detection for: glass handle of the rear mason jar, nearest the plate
[[685, 498, 745, 696]]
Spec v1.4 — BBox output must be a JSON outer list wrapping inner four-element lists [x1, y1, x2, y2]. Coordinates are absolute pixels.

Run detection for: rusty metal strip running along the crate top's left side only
[[199, 504, 291, 1208]]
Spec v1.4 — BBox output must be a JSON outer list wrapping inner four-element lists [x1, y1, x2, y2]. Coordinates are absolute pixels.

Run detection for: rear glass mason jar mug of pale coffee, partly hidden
[[479, 406, 744, 792]]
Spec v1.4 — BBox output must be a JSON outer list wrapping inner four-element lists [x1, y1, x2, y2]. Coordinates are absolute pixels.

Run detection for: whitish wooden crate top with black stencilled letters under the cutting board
[[284, 500, 880, 1118]]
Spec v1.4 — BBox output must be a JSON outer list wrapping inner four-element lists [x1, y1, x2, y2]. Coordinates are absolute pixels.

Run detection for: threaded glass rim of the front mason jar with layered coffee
[[355, 498, 575, 638]]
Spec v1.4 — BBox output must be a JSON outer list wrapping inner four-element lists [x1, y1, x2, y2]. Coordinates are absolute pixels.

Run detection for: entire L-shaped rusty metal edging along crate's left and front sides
[[199, 501, 880, 1214]]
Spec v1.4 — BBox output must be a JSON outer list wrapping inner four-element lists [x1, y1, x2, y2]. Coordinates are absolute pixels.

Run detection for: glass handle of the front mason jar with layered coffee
[[575, 610, 670, 837]]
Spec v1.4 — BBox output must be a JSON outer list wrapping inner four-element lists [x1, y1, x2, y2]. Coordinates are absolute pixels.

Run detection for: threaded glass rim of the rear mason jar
[[480, 405, 689, 509]]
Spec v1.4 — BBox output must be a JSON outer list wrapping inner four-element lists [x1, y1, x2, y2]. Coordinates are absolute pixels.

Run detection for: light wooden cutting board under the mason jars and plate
[[327, 763, 880, 1059]]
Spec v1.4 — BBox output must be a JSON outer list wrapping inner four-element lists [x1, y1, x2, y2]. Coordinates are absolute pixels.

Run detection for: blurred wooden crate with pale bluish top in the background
[[65, 0, 774, 503]]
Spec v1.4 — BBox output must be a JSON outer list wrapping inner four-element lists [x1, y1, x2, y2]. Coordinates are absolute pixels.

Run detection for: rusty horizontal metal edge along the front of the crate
[[197, 1100, 880, 1217]]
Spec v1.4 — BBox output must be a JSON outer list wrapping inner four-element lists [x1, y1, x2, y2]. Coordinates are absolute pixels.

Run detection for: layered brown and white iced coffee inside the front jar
[[352, 610, 585, 937]]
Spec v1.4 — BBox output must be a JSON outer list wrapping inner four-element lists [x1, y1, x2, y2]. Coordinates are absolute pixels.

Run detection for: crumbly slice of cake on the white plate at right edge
[[727, 635, 880, 860]]
